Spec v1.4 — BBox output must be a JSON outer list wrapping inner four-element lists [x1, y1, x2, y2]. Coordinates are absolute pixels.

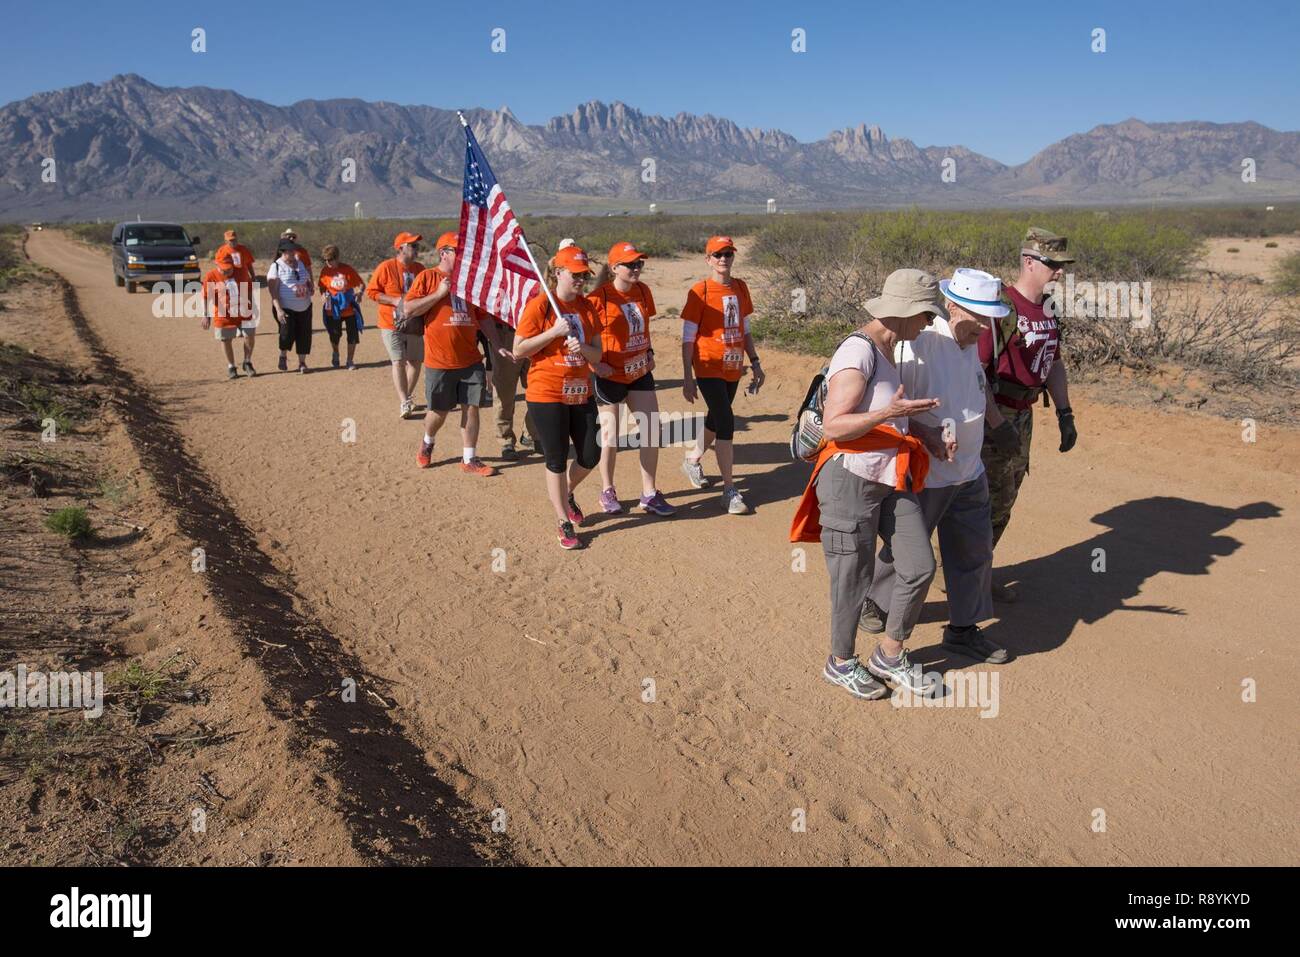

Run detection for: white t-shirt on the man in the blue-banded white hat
[[894, 316, 985, 489]]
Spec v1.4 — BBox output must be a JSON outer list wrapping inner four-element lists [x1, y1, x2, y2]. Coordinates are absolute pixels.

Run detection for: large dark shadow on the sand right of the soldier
[[985, 495, 1282, 655]]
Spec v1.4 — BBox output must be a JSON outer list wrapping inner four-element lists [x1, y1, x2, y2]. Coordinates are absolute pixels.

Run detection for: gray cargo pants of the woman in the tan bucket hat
[[816, 459, 935, 658]]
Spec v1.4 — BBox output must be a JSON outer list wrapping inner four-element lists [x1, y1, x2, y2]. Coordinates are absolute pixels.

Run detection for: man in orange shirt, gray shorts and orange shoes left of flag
[[406, 233, 510, 477]]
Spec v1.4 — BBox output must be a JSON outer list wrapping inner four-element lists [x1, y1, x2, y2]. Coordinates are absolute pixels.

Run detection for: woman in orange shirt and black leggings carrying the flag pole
[[512, 246, 612, 549]]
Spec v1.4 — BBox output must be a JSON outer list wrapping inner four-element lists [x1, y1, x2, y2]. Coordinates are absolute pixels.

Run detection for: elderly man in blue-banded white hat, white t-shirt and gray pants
[[862, 269, 1019, 664]]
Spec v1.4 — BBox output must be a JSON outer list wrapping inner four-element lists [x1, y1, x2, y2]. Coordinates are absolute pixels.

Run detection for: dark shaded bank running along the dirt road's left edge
[[57, 276, 514, 865]]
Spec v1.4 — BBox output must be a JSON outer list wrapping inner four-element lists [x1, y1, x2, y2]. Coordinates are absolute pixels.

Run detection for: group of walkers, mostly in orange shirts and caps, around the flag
[[204, 230, 764, 549]]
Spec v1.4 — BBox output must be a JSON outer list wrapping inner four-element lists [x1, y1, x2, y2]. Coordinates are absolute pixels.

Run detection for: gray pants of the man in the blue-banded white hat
[[871, 472, 993, 627]]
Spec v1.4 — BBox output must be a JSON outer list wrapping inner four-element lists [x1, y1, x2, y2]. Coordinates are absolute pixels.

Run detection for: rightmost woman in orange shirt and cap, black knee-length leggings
[[681, 235, 766, 515]]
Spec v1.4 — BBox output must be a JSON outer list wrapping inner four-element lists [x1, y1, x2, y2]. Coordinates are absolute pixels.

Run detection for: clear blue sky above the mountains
[[0, 0, 1300, 163]]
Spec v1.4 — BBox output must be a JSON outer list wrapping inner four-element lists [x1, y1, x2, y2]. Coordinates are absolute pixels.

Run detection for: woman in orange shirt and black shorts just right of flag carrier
[[588, 243, 676, 516]]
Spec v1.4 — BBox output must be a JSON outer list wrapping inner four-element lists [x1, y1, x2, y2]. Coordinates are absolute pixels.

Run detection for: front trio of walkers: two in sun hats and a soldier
[[790, 228, 1078, 698]]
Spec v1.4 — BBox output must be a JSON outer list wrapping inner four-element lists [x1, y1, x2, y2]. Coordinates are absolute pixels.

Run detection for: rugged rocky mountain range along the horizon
[[0, 74, 1300, 221]]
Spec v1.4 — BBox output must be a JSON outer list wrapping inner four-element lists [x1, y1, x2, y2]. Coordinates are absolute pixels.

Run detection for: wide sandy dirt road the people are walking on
[[29, 231, 1300, 865]]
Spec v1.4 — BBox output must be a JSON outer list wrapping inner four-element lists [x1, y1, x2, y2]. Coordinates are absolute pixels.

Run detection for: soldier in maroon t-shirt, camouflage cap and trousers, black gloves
[[979, 226, 1079, 602]]
